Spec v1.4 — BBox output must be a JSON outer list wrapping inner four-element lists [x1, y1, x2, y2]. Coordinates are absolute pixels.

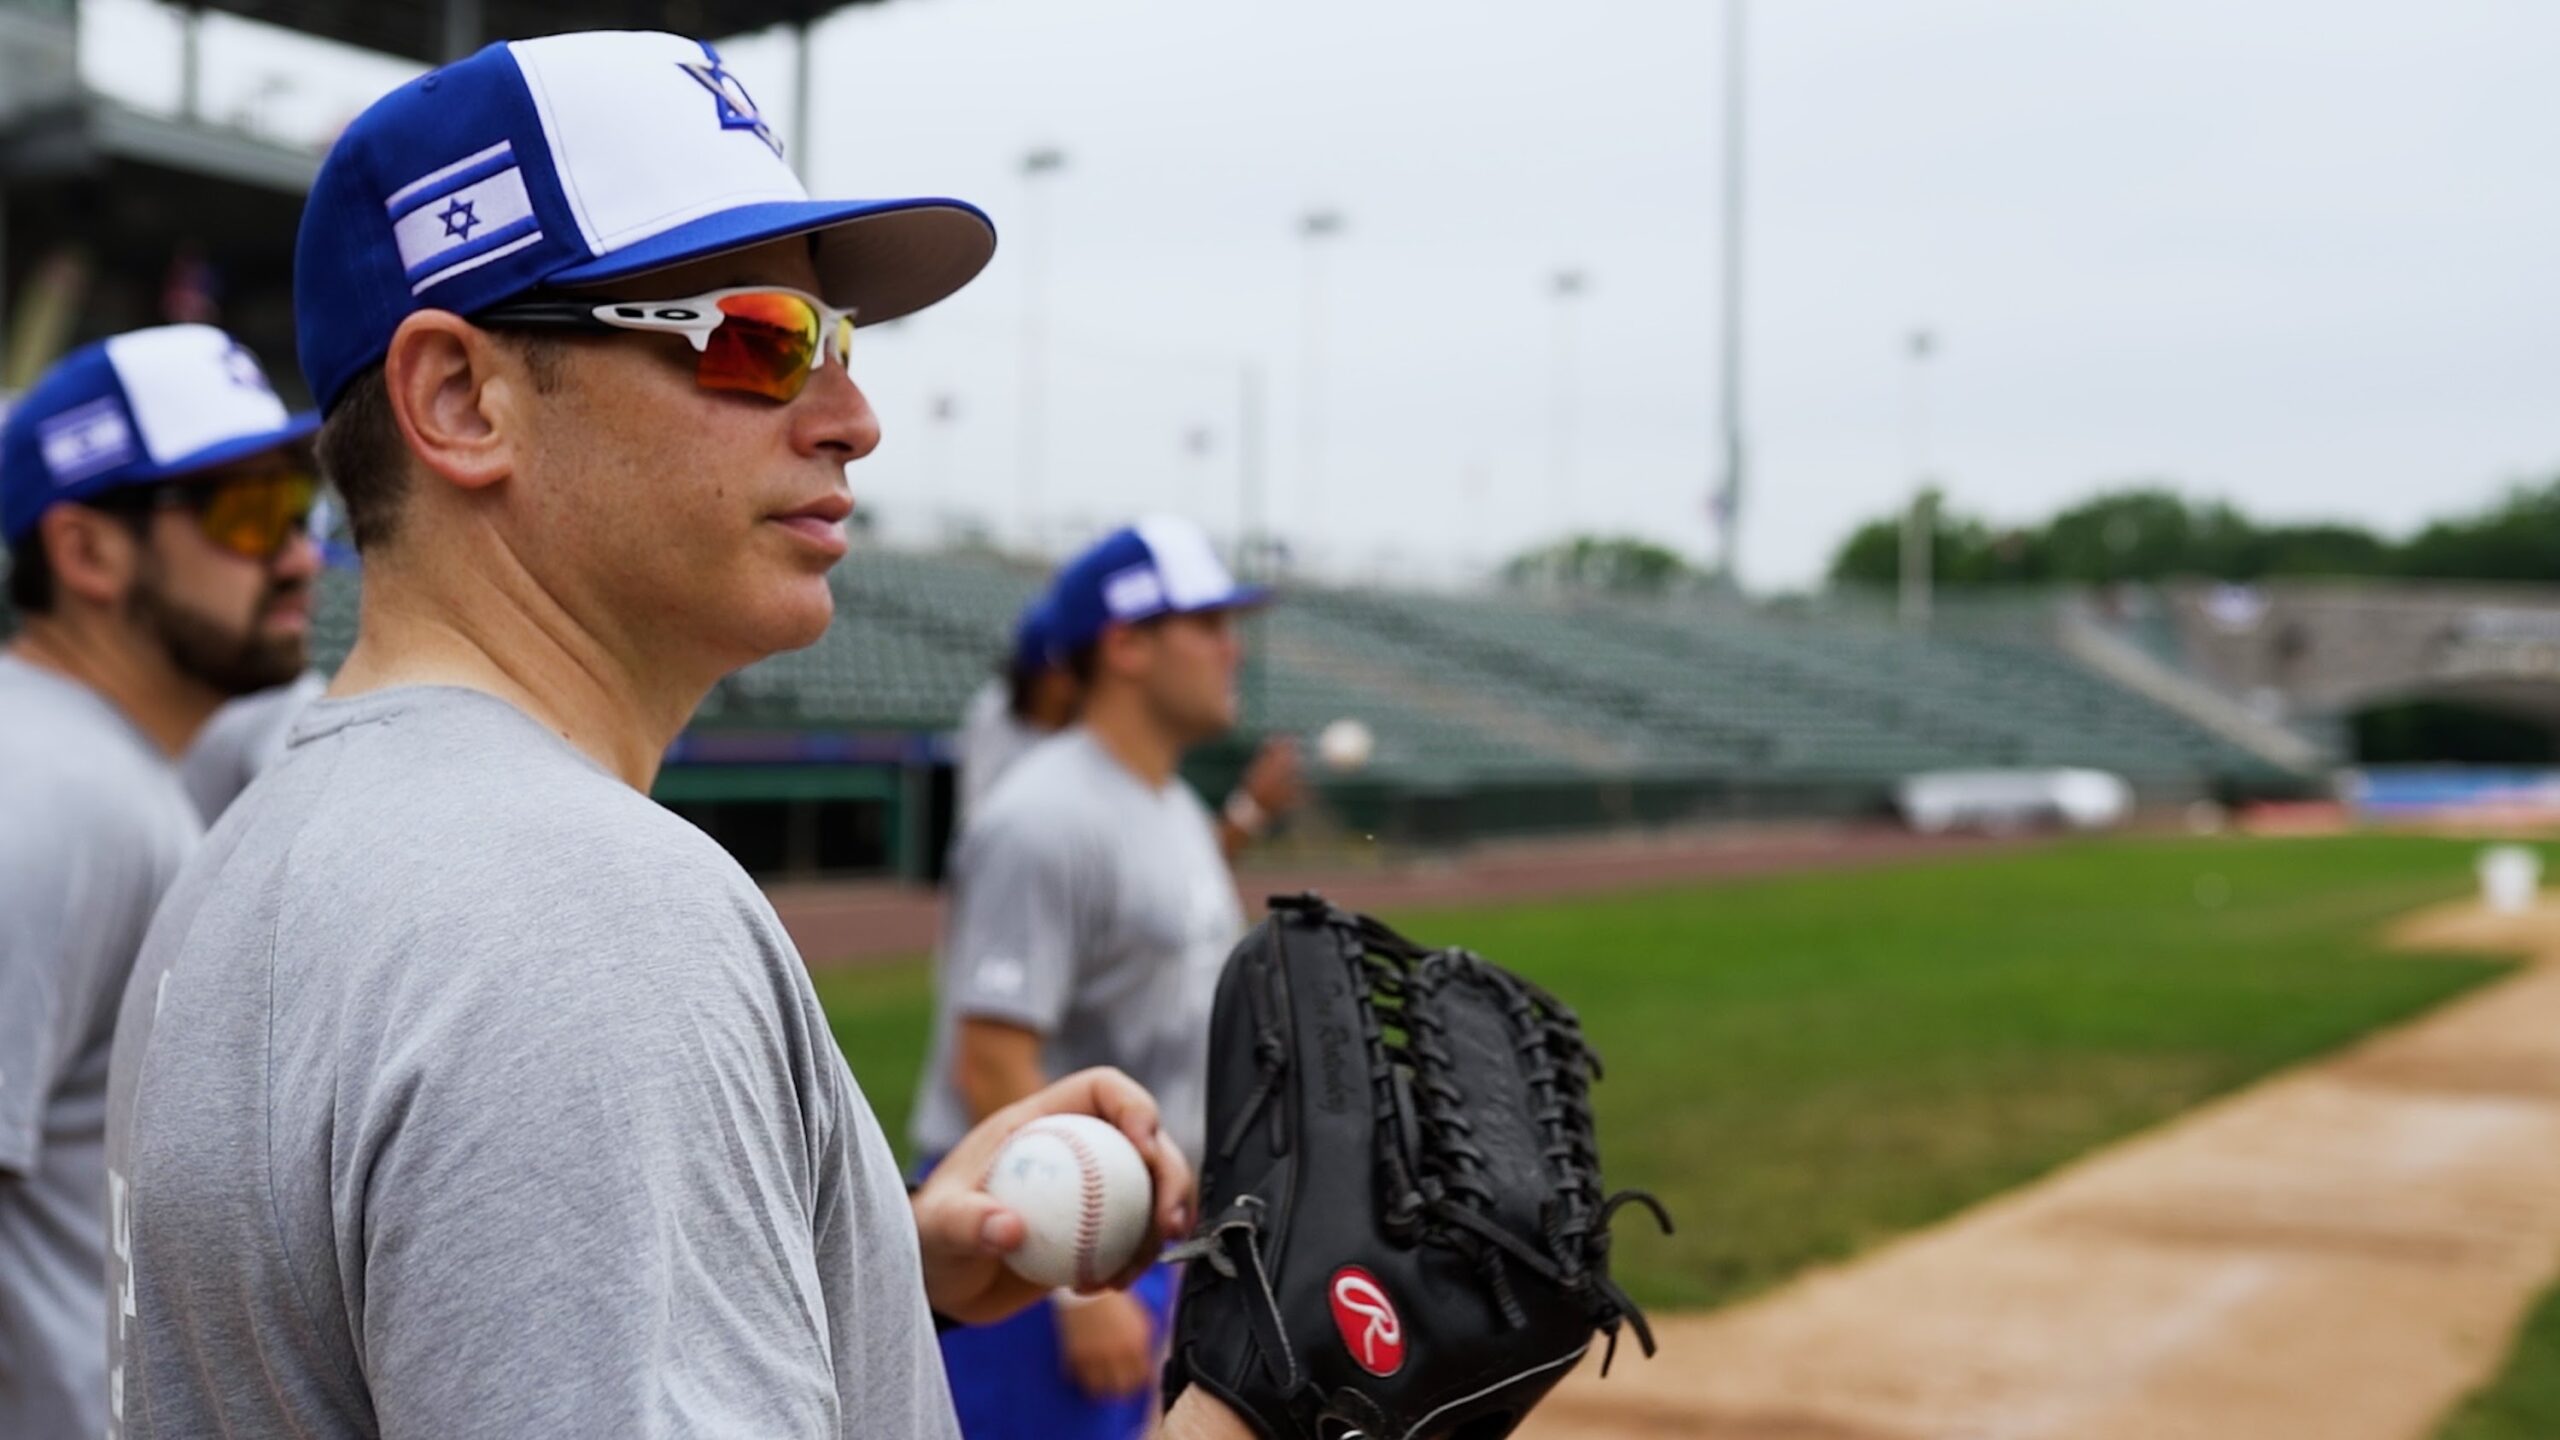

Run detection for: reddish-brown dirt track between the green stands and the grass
[[765, 825, 2035, 969]]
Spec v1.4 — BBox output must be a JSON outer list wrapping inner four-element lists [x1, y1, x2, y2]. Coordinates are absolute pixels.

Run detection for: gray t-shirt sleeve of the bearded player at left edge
[[0, 833, 69, 1176]]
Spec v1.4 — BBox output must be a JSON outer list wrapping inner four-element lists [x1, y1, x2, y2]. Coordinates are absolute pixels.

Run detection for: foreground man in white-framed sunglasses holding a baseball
[[108, 33, 1236, 1440]]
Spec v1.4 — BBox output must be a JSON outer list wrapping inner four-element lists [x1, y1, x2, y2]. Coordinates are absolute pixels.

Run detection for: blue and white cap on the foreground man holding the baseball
[[294, 31, 996, 410]]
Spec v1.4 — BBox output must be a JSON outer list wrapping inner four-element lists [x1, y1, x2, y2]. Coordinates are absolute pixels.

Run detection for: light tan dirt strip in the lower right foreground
[[1523, 891, 2560, 1440]]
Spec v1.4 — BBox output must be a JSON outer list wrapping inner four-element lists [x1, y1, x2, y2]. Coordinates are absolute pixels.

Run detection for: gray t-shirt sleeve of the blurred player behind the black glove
[[945, 812, 1088, 1035]]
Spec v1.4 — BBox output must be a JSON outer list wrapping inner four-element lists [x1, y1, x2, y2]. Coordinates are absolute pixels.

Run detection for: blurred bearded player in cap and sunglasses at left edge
[[0, 325, 320, 1437]]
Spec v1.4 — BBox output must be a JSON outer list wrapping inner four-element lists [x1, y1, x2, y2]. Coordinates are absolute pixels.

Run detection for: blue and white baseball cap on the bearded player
[[0, 325, 320, 543]]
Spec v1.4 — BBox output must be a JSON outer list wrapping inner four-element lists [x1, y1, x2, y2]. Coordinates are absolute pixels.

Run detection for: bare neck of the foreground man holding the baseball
[[330, 543, 717, 792]]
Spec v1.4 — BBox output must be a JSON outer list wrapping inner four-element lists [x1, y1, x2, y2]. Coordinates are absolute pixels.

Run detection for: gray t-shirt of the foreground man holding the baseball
[[108, 687, 957, 1440]]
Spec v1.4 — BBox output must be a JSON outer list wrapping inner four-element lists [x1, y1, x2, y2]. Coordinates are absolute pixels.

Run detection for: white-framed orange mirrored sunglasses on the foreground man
[[471, 287, 852, 400]]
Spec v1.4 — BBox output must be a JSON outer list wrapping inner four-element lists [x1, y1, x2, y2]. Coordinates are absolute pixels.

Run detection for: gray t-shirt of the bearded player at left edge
[[0, 656, 197, 1435]]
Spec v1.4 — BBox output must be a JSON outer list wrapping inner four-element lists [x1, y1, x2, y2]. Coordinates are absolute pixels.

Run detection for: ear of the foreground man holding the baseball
[[381, 310, 532, 489]]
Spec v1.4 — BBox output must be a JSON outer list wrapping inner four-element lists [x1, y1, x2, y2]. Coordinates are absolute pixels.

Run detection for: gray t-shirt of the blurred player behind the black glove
[[914, 728, 1244, 1161]]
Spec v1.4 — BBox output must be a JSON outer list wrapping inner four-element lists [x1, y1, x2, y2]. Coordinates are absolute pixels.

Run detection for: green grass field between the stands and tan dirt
[[819, 838, 2504, 1307]]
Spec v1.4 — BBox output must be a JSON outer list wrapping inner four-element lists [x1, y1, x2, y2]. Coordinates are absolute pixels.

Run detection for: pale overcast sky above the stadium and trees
[[84, 0, 2560, 589]]
